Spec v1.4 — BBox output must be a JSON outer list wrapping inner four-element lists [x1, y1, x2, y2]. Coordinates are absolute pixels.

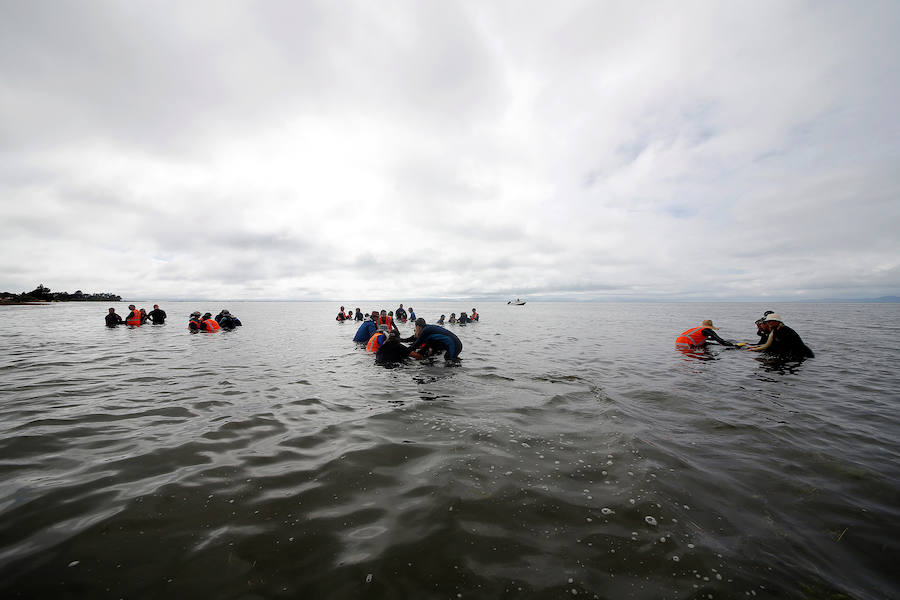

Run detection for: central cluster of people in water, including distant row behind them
[[346, 304, 479, 363]]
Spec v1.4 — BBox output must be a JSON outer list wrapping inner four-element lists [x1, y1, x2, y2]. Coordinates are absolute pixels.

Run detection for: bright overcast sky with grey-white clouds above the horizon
[[0, 0, 900, 301]]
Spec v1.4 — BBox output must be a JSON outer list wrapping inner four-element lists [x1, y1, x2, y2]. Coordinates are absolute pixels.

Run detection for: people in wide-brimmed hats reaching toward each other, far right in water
[[675, 310, 815, 359]]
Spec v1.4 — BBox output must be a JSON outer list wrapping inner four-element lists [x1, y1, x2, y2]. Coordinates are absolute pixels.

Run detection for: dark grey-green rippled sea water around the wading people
[[0, 302, 900, 599]]
